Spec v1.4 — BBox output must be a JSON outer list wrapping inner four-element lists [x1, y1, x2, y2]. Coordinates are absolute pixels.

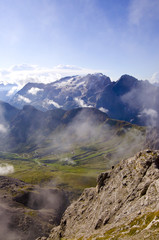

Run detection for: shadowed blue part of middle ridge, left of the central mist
[[0, 102, 108, 151]]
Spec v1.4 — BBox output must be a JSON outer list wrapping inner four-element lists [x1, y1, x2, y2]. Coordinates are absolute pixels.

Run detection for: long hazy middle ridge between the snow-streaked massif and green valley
[[0, 102, 145, 152]]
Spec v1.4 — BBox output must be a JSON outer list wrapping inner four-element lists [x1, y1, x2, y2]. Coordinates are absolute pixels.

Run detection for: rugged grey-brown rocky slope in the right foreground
[[41, 150, 159, 240]]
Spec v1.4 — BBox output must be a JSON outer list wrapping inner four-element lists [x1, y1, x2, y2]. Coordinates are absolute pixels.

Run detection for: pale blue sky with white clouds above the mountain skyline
[[0, 0, 159, 85]]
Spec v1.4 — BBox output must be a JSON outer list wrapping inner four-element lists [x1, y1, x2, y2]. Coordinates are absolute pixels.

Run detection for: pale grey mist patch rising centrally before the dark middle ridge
[[52, 109, 109, 151]]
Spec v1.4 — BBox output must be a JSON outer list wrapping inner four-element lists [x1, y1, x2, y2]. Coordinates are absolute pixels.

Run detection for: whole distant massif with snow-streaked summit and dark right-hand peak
[[10, 73, 159, 126]]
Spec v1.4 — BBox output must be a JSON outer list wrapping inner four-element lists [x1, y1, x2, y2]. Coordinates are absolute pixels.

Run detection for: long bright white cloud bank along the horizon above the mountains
[[0, 64, 101, 87]]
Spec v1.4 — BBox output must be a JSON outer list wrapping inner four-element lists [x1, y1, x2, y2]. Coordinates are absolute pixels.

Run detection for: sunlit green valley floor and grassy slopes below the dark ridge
[[0, 119, 145, 196]]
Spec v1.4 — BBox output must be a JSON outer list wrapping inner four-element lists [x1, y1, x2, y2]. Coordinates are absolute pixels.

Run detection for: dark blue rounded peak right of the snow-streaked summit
[[96, 75, 159, 126]]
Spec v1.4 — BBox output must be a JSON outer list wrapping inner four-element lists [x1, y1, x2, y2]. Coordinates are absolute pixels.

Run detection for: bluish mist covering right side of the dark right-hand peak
[[121, 81, 159, 127]]
